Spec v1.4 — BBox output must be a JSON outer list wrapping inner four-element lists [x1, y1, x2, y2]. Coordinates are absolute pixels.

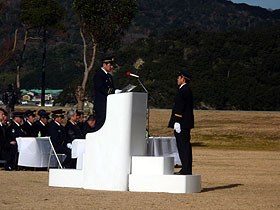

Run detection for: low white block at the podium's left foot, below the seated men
[[49, 169, 84, 188]]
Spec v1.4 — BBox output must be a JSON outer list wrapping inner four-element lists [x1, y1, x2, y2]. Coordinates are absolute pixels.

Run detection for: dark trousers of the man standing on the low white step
[[174, 129, 192, 175]]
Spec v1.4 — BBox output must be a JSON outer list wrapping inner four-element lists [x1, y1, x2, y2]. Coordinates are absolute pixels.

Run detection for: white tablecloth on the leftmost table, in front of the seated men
[[16, 137, 51, 168]]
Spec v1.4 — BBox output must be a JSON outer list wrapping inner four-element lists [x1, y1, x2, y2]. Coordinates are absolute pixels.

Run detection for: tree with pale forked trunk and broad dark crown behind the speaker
[[74, 0, 136, 109]]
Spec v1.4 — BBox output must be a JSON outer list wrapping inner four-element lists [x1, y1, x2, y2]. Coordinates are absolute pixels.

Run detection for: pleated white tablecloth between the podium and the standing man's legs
[[147, 137, 181, 164]]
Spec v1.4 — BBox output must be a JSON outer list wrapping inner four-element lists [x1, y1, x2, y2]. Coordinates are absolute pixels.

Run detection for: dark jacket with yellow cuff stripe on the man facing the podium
[[168, 84, 194, 129]]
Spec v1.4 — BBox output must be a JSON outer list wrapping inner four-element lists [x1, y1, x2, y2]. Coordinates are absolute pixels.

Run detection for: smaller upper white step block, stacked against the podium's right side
[[131, 156, 174, 175]]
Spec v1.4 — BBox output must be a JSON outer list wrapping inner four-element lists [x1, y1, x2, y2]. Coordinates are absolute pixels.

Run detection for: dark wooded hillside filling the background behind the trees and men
[[0, 0, 280, 110]]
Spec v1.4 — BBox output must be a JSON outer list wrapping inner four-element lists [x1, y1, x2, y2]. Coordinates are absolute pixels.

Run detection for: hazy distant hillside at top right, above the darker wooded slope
[[130, 0, 280, 38]]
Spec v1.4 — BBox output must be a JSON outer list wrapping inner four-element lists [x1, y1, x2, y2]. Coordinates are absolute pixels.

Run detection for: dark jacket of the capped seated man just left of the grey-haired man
[[48, 121, 66, 150]]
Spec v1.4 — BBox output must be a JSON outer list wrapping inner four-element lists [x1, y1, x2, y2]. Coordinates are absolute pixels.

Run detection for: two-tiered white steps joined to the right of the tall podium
[[129, 156, 201, 193]]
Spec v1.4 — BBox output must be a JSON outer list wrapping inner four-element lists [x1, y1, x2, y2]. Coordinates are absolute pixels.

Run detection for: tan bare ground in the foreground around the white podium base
[[0, 147, 280, 210]]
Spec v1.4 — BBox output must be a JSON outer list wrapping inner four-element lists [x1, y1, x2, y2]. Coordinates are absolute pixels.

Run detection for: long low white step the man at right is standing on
[[129, 174, 201, 193]]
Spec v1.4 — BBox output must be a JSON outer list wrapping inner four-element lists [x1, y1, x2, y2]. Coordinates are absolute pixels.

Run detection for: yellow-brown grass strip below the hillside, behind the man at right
[[150, 110, 280, 151]]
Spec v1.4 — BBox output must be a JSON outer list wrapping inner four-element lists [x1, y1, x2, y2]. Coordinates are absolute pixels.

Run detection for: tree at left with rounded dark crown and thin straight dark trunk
[[20, 0, 64, 106]]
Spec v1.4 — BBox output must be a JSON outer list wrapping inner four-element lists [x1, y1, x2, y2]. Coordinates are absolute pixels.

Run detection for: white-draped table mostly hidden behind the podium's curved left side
[[71, 139, 86, 169]]
